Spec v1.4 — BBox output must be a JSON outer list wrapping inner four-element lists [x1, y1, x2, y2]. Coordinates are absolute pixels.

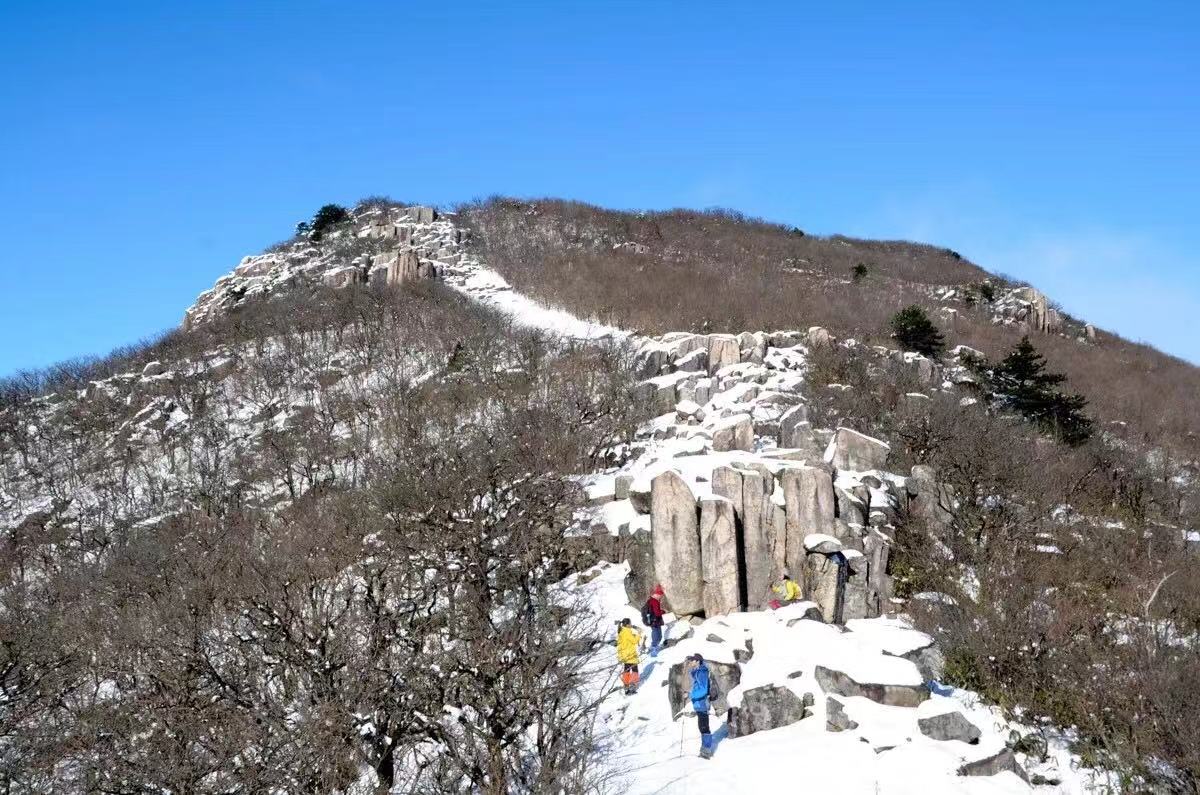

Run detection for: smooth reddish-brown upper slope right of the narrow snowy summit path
[[460, 198, 1200, 458]]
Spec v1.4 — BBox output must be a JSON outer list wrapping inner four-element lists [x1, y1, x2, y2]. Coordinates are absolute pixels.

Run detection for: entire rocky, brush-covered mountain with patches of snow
[[0, 198, 1200, 794]]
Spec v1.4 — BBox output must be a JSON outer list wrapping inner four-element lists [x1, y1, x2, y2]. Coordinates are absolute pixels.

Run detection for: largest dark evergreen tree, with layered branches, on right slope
[[991, 336, 1092, 444]]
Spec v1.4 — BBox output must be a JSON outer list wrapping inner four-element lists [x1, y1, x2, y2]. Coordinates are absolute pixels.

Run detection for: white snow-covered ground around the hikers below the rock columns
[[566, 564, 1103, 795]]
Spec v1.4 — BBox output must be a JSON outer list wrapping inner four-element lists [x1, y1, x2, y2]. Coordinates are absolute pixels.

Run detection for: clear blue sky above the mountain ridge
[[0, 0, 1200, 373]]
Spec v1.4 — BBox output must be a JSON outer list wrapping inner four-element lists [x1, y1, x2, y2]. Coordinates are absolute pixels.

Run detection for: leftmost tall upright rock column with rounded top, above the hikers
[[650, 470, 704, 615]]
